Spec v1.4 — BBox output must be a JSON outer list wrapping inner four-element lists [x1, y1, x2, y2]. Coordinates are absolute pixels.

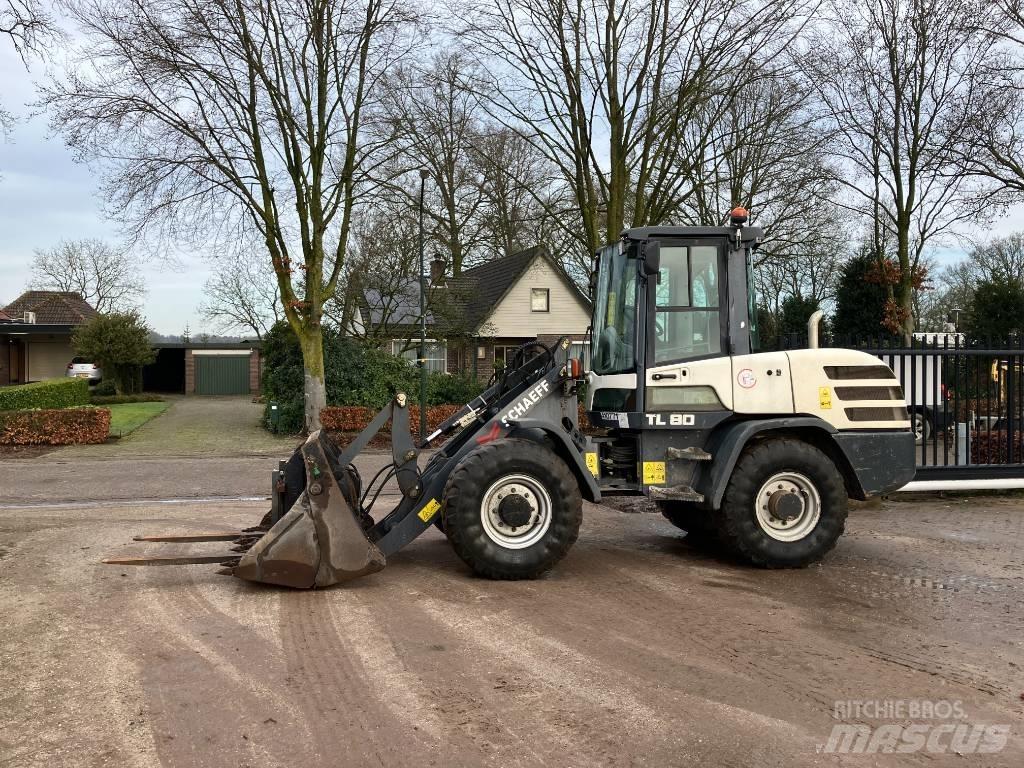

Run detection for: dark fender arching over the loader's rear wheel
[[694, 416, 843, 509]]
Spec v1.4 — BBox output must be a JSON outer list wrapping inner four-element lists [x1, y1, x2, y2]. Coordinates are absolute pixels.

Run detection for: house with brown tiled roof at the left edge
[[0, 291, 98, 386]]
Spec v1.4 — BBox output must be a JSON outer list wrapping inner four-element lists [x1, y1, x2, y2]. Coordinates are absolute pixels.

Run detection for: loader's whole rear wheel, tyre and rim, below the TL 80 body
[[720, 438, 848, 568]]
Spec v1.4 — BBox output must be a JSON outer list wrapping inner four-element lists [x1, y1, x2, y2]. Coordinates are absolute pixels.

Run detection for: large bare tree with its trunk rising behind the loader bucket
[[45, 0, 415, 430]]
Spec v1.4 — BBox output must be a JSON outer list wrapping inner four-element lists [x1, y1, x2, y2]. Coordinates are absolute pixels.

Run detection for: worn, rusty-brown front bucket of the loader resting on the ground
[[231, 431, 385, 589]]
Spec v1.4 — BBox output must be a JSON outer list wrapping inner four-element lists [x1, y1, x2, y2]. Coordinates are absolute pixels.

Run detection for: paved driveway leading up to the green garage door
[[55, 395, 297, 460]]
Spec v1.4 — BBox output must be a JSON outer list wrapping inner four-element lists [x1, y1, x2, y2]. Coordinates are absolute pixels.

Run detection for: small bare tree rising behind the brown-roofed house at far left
[[30, 240, 145, 312]]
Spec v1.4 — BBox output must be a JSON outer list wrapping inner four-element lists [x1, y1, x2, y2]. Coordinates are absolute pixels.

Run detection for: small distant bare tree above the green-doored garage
[[200, 249, 284, 339]]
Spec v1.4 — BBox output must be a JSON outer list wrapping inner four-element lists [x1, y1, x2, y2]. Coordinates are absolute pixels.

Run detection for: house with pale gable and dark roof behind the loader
[[356, 246, 591, 379]]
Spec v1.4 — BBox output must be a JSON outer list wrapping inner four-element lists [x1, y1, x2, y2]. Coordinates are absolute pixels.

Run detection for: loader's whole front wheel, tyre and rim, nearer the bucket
[[442, 438, 583, 580]]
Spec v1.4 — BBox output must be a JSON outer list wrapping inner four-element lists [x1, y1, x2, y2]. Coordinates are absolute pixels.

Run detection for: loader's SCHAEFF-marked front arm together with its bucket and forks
[[109, 338, 600, 589]]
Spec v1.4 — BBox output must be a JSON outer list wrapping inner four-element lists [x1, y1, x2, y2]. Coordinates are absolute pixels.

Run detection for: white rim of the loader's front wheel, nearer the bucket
[[480, 474, 551, 549]]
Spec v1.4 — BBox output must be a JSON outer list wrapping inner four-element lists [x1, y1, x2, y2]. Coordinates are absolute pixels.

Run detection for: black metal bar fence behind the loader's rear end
[[781, 334, 1024, 480]]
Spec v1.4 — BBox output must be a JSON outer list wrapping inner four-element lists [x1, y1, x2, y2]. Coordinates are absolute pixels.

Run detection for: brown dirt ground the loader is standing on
[[0, 479, 1024, 768]]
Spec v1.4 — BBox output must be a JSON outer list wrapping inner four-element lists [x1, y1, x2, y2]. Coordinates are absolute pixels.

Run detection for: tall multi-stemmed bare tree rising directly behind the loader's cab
[[461, 0, 803, 259]]
